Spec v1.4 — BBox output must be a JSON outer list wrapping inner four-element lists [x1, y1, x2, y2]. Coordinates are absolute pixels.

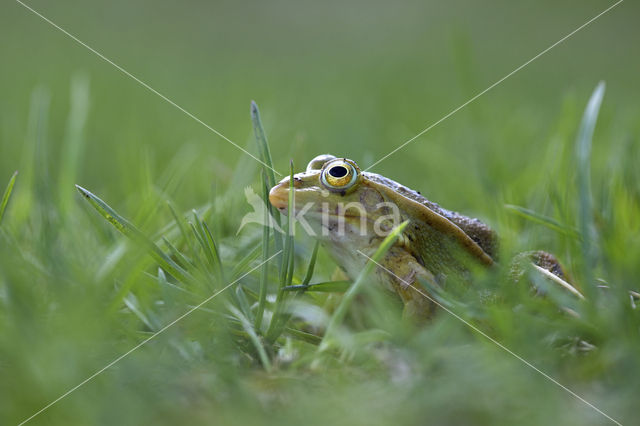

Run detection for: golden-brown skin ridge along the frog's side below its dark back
[[378, 186, 494, 265]]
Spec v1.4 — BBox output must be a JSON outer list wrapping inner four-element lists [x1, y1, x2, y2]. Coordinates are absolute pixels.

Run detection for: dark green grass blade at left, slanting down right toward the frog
[[76, 185, 194, 283]]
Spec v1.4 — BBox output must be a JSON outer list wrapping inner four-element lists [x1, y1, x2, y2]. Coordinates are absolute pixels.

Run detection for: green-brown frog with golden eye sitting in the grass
[[269, 154, 571, 318]]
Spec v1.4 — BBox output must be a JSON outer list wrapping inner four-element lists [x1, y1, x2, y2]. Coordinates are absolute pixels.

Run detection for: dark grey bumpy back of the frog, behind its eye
[[366, 173, 498, 260]]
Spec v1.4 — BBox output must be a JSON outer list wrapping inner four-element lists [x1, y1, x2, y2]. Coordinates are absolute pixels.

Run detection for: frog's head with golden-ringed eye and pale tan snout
[[269, 154, 399, 245]]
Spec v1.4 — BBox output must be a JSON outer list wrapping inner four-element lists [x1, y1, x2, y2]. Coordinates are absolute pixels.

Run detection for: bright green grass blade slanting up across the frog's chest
[[318, 221, 409, 353]]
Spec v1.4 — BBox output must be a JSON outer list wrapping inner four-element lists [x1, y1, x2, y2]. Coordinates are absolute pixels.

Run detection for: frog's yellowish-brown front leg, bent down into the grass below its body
[[376, 247, 437, 320]]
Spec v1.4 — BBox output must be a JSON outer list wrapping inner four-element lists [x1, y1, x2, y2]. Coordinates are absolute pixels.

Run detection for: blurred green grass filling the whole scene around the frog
[[0, 0, 640, 425]]
